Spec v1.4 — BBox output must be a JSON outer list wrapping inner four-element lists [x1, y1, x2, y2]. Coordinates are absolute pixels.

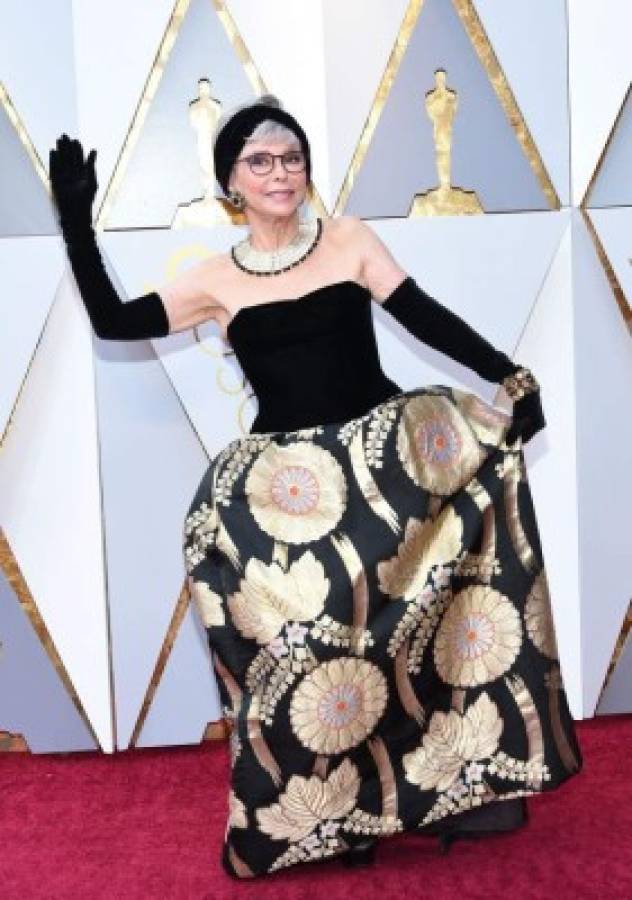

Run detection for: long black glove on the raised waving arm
[[50, 134, 169, 340]]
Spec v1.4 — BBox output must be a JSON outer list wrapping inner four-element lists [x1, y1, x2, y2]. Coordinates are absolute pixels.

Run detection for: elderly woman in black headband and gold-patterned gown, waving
[[50, 95, 581, 878]]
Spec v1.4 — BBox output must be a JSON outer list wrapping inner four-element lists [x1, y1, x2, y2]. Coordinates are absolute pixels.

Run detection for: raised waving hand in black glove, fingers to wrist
[[49, 134, 98, 234]]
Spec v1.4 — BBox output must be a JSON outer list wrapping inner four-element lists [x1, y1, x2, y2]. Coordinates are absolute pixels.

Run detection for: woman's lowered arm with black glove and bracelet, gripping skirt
[[354, 219, 545, 440]]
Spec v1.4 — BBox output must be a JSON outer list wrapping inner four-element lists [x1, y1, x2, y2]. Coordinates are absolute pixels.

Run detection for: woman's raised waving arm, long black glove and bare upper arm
[[50, 135, 216, 340]]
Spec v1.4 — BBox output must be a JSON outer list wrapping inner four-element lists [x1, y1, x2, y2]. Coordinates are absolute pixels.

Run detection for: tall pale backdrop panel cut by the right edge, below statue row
[[573, 211, 632, 715]]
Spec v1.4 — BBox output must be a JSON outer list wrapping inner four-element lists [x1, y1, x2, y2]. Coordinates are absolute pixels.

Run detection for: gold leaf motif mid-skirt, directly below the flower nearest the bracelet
[[376, 506, 463, 600]]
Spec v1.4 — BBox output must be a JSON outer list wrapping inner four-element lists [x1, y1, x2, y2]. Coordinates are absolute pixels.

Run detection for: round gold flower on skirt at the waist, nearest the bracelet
[[397, 394, 485, 495]]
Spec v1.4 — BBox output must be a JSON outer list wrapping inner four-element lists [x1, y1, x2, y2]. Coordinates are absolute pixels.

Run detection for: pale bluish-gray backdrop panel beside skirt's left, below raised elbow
[[96, 341, 207, 748]]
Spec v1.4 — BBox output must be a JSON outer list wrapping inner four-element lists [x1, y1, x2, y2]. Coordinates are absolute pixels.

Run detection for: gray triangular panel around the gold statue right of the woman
[[344, 0, 549, 218]]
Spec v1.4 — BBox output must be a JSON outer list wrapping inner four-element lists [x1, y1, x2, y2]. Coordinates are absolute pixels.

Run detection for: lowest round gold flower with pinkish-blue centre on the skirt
[[290, 657, 388, 754]]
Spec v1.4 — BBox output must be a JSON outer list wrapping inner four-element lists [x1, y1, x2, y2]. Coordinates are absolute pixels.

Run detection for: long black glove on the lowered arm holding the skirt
[[382, 275, 546, 444]]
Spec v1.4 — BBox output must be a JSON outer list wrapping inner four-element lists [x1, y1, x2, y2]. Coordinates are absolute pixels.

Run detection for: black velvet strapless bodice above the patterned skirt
[[226, 281, 401, 433]]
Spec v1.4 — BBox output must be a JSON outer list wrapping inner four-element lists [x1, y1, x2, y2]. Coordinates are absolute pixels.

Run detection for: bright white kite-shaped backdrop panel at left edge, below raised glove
[[0, 278, 112, 751]]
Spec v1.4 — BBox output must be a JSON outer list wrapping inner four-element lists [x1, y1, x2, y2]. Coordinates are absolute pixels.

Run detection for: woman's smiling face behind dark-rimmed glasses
[[228, 140, 307, 216]]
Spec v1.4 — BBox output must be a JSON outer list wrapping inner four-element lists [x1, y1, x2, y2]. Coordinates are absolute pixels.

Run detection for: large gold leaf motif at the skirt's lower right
[[403, 692, 503, 791]]
